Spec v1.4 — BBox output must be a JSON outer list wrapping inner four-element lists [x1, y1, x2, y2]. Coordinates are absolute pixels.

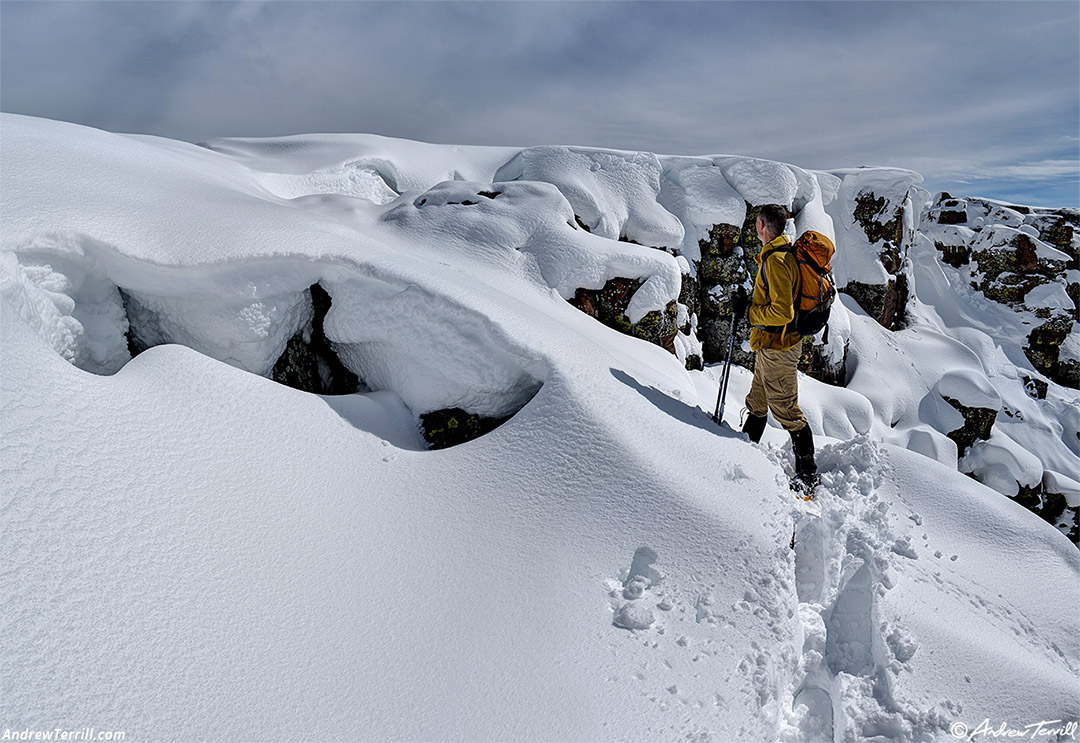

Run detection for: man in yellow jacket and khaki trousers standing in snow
[[733, 204, 818, 494]]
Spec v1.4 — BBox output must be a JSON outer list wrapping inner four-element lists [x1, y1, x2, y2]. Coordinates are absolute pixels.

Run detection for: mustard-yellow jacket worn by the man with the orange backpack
[[750, 234, 802, 351]]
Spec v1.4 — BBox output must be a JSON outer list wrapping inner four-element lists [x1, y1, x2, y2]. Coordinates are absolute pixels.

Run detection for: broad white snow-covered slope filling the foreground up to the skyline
[[0, 116, 1080, 741]]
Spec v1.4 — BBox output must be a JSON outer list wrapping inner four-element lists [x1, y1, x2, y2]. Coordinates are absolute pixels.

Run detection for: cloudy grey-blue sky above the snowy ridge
[[0, 0, 1080, 206]]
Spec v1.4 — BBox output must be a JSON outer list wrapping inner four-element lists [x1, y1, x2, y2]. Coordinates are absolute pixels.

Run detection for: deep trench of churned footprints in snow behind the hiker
[[782, 436, 949, 743]]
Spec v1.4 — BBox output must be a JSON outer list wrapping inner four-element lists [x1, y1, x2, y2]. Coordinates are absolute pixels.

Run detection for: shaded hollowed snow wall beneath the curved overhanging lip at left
[[3, 232, 543, 416]]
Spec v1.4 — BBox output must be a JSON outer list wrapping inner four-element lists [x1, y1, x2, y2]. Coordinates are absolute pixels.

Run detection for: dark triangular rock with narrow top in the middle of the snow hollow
[[270, 284, 360, 394]]
